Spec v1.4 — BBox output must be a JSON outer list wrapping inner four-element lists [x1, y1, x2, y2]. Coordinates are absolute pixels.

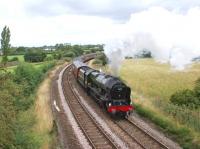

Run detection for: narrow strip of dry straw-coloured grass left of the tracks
[[34, 62, 65, 149]]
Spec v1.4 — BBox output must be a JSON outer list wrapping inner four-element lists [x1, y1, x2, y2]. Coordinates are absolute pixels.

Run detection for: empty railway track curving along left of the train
[[62, 66, 118, 149]]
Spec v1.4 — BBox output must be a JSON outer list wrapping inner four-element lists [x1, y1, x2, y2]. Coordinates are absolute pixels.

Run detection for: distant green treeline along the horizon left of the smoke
[[5, 44, 104, 62]]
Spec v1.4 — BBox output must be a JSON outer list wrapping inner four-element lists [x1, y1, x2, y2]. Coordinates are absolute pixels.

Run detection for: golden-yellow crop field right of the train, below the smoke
[[120, 59, 200, 100]]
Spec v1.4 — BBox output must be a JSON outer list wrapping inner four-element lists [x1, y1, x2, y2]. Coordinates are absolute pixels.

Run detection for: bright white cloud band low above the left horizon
[[0, 15, 118, 46]]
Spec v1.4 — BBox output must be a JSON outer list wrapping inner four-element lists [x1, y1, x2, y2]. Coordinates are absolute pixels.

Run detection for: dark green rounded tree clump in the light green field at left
[[24, 50, 47, 62]]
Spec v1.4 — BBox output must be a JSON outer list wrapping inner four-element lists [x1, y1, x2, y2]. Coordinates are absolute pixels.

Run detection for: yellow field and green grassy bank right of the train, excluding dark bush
[[92, 59, 200, 148]]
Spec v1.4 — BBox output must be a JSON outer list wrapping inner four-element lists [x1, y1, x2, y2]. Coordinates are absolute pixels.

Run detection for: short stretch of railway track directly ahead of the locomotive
[[115, 118, 169, 149]]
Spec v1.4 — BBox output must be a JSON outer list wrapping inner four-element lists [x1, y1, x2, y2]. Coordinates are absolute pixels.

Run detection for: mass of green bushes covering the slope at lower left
[[0, 62, 55, 149]]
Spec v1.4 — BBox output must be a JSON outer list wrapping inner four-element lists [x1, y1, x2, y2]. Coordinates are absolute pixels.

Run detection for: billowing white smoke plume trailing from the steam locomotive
[[105, 7, 200, 74]]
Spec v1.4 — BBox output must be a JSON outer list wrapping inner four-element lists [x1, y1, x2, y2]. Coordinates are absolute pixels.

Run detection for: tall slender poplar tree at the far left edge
[[1, 26, 10, 66]]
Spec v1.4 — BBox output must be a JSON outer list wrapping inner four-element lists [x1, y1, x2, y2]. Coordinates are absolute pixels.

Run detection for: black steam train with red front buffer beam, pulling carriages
[[72, 54, 134, 117]]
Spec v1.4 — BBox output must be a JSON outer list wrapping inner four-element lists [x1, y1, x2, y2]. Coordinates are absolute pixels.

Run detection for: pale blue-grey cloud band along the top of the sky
[[26, 0, 200, 21]]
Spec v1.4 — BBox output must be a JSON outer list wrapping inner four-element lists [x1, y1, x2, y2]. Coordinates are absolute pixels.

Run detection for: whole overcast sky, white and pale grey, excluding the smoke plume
[[0, 0, 200, 46]]
